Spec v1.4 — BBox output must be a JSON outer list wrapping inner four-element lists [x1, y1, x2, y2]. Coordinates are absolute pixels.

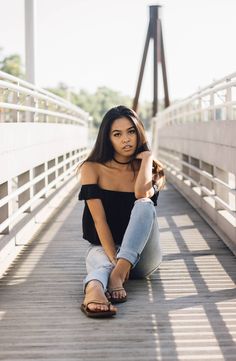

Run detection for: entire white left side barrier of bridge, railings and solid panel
[[0, 71, 89, 242]]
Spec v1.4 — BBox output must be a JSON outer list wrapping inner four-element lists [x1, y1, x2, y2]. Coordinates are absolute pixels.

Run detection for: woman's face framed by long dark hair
[[110, 117, 137, 157]]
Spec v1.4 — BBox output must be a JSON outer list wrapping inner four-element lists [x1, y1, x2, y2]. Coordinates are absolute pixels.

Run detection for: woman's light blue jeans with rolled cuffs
[[84, 198, 162, 291]]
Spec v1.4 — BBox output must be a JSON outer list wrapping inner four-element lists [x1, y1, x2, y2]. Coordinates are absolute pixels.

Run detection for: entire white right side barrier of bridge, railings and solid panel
[[152, 73, 236, 252]]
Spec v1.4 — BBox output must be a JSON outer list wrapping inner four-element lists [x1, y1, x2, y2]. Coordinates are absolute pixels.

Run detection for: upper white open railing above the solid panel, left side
[[0, 71, 88, 125]]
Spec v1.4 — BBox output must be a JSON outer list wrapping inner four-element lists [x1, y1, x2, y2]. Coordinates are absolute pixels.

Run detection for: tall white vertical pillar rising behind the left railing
[[25, 0, 36, 84]]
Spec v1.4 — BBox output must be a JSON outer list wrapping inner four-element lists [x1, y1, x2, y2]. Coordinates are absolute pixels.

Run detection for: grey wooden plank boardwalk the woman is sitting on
[[0, 186, 236, 361]]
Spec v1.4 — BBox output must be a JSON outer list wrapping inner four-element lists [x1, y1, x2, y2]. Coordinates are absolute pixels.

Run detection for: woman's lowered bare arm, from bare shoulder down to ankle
[[80, 162, 116, 263]]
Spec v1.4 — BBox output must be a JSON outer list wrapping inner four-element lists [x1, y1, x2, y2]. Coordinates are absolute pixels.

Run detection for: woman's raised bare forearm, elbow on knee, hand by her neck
[[134, 151, 154, 199]]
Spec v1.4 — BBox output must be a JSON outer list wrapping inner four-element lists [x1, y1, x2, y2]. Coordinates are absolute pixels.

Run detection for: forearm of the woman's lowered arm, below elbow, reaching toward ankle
[[95, 220, 116, 263]]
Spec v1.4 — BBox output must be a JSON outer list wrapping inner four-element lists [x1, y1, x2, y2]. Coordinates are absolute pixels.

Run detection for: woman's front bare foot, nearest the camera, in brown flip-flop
[[84, 280, 117, 312]]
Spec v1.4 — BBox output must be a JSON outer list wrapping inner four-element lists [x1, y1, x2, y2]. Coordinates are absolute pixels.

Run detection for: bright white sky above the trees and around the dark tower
[[0, 0, 236, 100]]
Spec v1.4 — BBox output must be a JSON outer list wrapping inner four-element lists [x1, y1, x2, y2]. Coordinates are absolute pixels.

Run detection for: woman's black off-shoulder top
[[79, 184, 159, 245]]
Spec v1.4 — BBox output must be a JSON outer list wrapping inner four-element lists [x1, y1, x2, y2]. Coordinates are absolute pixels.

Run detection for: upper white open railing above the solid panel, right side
[[158, 73, 236, 128]]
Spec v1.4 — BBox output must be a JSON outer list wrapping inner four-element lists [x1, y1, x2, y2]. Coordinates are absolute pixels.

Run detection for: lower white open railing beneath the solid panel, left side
[[0, 148, 87, 234]]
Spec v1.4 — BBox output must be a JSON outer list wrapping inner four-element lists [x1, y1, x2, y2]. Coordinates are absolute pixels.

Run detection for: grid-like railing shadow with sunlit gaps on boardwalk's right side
[[130, 186, 236, 360]]
